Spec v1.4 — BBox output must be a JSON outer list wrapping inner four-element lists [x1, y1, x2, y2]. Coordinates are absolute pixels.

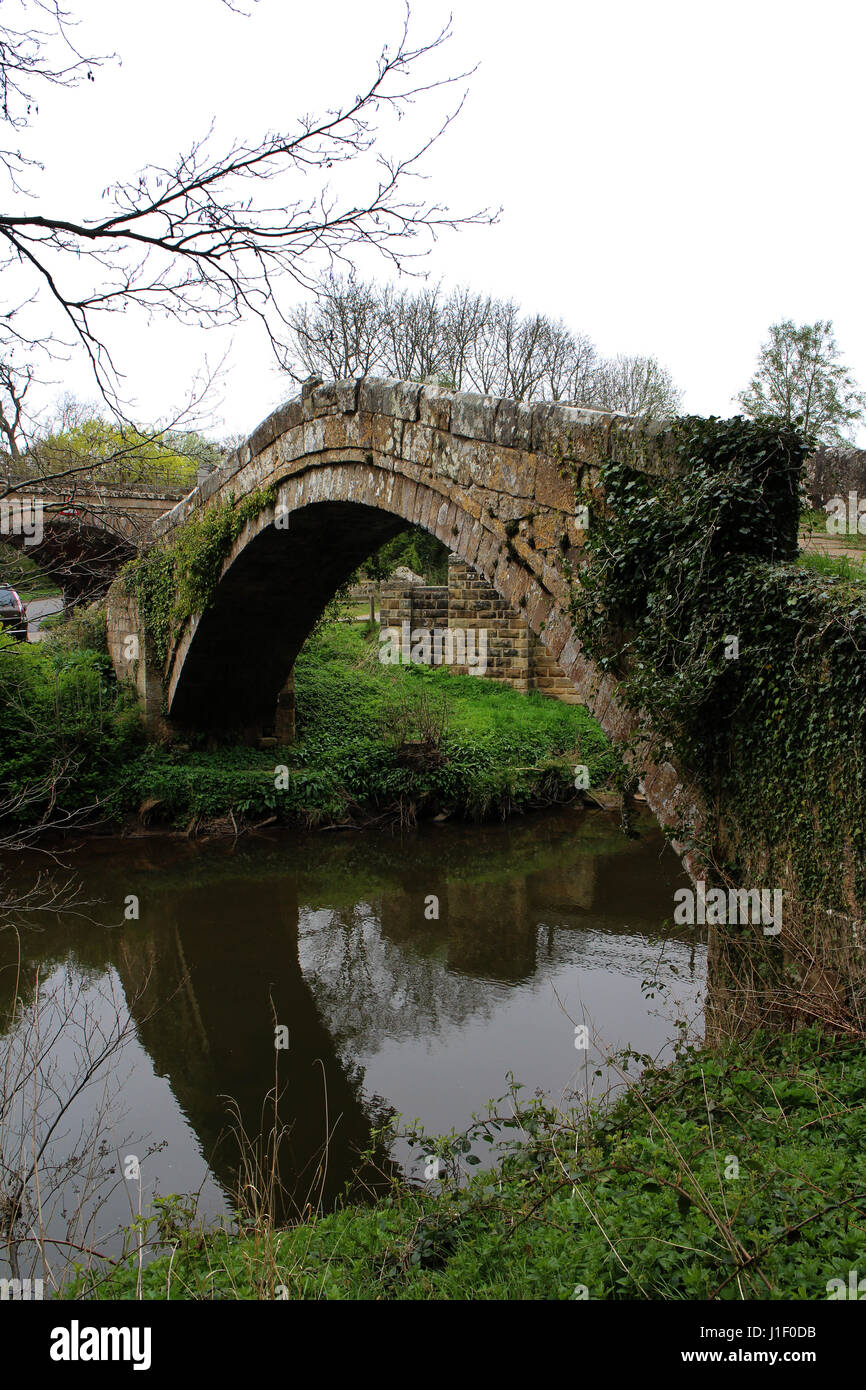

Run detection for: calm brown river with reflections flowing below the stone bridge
[[0, 809, 706, 1284]]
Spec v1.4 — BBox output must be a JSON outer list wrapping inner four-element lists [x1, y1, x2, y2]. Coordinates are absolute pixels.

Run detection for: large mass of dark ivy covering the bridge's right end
[[573, 417, 866, 919]]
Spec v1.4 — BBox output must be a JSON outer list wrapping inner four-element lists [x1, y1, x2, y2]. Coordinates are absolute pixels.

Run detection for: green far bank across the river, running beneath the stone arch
[[0, 612, 620, 828]]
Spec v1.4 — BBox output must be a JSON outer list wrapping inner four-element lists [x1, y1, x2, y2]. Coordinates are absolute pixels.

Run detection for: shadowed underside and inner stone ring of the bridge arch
[[165, 456, 572, 730]]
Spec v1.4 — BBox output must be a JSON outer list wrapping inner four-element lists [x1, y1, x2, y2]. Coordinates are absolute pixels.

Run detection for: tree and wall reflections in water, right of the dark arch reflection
[[299, 837, 703, 1061]]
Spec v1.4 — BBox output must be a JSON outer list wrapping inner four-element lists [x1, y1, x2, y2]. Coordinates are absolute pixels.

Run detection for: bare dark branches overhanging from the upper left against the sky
[[0, 0, 491, 406]]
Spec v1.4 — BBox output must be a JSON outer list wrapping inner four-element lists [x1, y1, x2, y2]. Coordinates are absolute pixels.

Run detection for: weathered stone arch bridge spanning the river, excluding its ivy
[[108, 378, 701, 861]]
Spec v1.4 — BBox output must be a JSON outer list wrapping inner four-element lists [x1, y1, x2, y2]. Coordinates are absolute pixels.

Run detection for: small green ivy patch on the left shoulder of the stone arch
[[121, 488, 277, 662]]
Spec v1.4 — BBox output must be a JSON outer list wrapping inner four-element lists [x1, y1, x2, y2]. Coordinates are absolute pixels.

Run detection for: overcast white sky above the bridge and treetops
[[6, 0, 866, 442]]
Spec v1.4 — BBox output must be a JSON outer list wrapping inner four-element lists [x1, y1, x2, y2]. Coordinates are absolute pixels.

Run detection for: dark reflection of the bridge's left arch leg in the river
[[115, 878, 385, 1205]]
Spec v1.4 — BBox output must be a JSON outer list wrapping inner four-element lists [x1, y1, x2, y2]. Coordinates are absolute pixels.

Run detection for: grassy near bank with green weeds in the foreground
[[71, 1029, 866, 1300]]
